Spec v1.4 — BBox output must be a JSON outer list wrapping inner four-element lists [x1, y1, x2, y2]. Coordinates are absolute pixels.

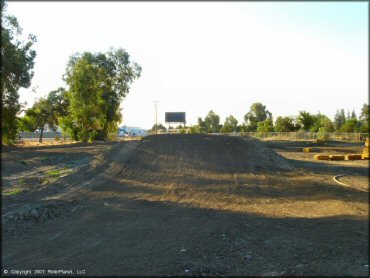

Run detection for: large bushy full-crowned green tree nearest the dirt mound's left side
[[64, 48, 141, 142]]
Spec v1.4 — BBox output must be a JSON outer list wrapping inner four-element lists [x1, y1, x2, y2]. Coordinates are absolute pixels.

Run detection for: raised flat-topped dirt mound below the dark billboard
[[131, 134, 291, 173]]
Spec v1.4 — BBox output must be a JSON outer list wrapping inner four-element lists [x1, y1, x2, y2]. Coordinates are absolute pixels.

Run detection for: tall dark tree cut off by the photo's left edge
[[0, 1, 36, 143]]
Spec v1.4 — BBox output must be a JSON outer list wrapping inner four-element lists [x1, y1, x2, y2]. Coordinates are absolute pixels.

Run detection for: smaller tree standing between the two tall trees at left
[[25, 88, 68, 143]]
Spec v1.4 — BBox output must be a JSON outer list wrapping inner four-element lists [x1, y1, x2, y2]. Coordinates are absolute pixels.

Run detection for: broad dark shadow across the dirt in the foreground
[[2, 197, 368, 277]]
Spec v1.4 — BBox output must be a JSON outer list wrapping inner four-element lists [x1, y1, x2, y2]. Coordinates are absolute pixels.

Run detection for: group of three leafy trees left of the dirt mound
[[1, 0, 142, 144]]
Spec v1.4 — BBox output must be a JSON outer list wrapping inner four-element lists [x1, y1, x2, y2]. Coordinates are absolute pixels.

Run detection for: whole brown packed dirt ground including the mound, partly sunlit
[[2, 134, 369, 276]]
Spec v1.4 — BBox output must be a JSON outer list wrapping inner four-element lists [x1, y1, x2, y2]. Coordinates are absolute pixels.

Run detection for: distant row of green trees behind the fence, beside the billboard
[[152, 102, 370, 133]]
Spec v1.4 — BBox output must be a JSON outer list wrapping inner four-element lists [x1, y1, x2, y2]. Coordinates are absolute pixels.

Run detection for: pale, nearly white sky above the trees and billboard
[[7, 1, 369, 128]]
